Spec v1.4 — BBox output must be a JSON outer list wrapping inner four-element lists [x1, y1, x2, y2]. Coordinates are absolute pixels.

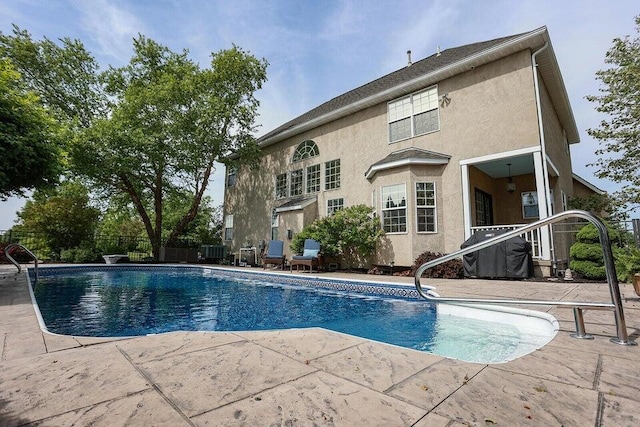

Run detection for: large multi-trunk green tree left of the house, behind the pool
[[71, 36, 267, 257]]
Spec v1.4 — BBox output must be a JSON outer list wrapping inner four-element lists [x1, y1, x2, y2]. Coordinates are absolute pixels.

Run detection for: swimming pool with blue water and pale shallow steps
[[33, 266, 557, 363]]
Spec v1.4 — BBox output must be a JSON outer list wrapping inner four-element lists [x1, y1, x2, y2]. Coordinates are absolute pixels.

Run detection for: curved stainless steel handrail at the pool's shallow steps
[[414, 210, 637, 345]]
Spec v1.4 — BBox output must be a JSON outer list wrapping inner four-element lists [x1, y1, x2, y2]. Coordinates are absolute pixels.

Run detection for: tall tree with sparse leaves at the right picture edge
[[587, 16, 640, 214]]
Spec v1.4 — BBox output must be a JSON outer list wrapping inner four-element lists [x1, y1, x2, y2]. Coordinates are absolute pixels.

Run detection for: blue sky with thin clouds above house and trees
[[0, 0, 640, 230]]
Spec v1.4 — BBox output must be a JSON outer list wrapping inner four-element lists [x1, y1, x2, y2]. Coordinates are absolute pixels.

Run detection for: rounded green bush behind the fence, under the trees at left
[[18, 182, 100, 253]]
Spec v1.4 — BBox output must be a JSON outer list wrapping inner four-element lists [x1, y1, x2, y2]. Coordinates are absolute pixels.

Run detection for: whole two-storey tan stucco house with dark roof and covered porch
[[224, 27, 600, 274]]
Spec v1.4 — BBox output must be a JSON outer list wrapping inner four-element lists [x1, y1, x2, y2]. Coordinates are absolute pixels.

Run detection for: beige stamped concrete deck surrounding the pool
[[0, 265, 640, 427]]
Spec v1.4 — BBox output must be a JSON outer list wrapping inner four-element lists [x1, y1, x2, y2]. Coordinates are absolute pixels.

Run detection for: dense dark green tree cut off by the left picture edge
[[0, 56, 61, 199]]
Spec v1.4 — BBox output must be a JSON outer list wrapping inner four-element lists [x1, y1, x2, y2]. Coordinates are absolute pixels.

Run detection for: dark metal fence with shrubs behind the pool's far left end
[[0, 230, 210, 262]]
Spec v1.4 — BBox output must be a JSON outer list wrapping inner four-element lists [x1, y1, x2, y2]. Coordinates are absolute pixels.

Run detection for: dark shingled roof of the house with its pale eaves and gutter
[[258, 27, 579, 146]]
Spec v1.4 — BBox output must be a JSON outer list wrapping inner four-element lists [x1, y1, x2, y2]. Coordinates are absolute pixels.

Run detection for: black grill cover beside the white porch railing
[[460, 230, 533, 279]]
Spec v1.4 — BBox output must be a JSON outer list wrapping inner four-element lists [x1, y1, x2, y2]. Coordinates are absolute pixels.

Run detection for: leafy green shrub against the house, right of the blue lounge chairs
[[291, 205, 384, 265]]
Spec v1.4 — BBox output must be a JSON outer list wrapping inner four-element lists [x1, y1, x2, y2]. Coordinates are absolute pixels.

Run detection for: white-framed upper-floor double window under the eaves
[[387, 86, 440, 142]]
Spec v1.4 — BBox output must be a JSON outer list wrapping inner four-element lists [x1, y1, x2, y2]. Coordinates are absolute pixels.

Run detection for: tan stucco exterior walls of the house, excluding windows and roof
[[225, 50, 571, 265]]
